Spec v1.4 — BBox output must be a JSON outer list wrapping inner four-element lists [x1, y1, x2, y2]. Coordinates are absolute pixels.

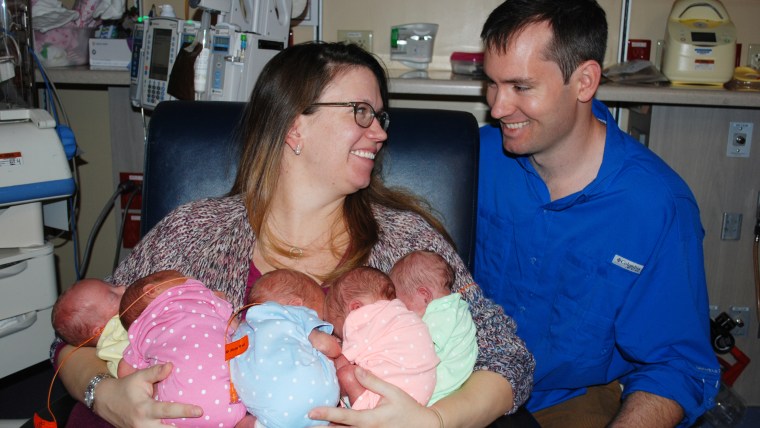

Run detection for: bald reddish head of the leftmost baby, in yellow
[[51, 278, 125, 346]]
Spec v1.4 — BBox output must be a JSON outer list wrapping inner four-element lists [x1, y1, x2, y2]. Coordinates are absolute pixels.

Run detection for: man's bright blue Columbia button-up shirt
[[474, 100, 720, 424]]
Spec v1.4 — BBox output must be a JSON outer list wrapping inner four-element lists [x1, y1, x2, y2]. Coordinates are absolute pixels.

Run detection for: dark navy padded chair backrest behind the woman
[[141, 101, 480, 266]]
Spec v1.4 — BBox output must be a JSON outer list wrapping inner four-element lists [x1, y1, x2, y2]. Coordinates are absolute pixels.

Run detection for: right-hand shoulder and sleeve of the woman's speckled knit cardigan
[[369, 207, 535, 413]]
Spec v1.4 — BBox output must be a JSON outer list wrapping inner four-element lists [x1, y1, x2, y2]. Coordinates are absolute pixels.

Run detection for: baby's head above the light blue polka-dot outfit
[[246, 269, 325, 318]]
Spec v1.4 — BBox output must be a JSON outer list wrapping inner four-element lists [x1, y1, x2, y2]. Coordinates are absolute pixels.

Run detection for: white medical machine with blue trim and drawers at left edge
[[0, 109, 75, 378]]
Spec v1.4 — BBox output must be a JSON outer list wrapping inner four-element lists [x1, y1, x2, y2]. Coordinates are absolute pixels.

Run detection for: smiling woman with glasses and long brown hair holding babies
[[55, 43, 534, 427]]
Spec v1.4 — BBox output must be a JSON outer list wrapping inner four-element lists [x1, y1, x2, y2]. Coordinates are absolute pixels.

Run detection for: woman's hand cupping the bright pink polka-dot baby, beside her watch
[[94, 363, 203, 428]]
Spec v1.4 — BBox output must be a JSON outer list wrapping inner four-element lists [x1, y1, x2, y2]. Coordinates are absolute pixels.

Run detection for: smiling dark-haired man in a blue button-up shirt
[[475, 0, 720, 427]]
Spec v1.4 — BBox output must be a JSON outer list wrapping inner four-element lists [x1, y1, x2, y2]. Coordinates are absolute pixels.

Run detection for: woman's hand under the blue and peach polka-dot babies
[[309, 367, 439, 428]]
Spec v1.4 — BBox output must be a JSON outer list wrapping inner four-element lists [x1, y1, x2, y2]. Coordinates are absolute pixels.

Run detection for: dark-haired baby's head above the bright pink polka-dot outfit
[[119, 270, 187, 330]]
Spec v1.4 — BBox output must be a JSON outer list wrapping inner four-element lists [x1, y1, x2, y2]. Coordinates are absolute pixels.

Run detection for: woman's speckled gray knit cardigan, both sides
[[67, 196, 535, 413]]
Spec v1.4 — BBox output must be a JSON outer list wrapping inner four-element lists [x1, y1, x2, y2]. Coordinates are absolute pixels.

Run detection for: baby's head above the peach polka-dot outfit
[[325, 266, 396, 338]]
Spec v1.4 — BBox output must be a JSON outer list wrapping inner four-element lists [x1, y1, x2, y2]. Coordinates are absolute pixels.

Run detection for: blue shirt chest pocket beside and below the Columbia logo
[[549, 246, 637, 365]]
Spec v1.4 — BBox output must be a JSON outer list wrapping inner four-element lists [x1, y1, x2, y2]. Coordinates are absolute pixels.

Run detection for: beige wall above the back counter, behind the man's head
[[323, 0, 760, 69]]
